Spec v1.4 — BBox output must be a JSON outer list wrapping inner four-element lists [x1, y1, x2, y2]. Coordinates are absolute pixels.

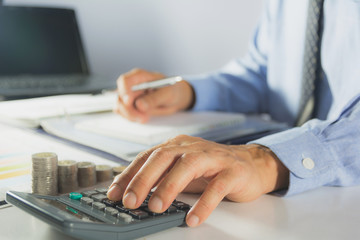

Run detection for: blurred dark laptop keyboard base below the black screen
[[0, 74, 88, 89]]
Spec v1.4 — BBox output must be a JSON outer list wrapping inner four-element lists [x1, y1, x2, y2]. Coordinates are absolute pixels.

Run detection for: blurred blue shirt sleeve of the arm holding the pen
[[184, 0, 270, 113]]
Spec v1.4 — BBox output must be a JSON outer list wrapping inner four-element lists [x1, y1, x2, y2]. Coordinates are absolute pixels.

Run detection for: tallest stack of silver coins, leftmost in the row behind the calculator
[[31, 152, 58, 195]]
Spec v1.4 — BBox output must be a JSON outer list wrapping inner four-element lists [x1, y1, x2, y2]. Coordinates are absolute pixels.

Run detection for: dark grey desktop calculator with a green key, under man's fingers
[[6, 188, 190, 240]]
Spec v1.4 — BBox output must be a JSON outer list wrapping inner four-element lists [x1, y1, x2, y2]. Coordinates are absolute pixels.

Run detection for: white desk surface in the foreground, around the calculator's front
[[0, 187, 360, 240]]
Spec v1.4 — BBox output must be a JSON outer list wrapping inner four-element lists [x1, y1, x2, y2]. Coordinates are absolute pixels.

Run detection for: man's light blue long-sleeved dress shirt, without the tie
[[187, 0, 360, 195]]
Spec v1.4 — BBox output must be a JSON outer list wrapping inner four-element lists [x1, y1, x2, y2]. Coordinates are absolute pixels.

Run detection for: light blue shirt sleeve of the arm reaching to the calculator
[[252, 94, 360, 195]]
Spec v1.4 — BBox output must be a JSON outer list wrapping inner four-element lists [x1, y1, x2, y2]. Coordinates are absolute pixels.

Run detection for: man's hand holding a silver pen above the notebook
[[115, 69, 195, 123]]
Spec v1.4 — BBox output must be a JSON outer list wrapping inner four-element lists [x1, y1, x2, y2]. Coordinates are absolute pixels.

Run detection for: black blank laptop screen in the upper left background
[[0, 6, 88, 76]]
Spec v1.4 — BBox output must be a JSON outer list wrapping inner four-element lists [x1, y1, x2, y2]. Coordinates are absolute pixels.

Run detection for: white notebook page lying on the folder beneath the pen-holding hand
[[75, 112, 245, 146]]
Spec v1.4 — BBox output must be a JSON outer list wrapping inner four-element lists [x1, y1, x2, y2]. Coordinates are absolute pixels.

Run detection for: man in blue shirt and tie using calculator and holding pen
[[108, 0, 360, 227]]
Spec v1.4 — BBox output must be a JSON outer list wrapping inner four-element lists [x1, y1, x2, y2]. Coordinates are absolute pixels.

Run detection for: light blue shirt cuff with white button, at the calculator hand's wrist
[[251, 127, 335, 196]]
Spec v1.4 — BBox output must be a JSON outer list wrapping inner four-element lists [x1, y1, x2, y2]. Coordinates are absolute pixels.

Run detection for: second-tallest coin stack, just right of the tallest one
[[58, 160, 78, 193]]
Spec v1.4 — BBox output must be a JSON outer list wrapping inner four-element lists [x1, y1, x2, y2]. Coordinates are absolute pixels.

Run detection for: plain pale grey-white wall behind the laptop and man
[[4, 0, 262, 78]]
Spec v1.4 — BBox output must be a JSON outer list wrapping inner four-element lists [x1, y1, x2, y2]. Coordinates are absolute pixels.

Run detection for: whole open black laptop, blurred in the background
[[0, 6, 116, 99]]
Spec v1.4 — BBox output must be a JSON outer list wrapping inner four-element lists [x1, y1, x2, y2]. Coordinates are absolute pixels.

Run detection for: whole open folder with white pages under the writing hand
[[41, 112, 285, 161]]
